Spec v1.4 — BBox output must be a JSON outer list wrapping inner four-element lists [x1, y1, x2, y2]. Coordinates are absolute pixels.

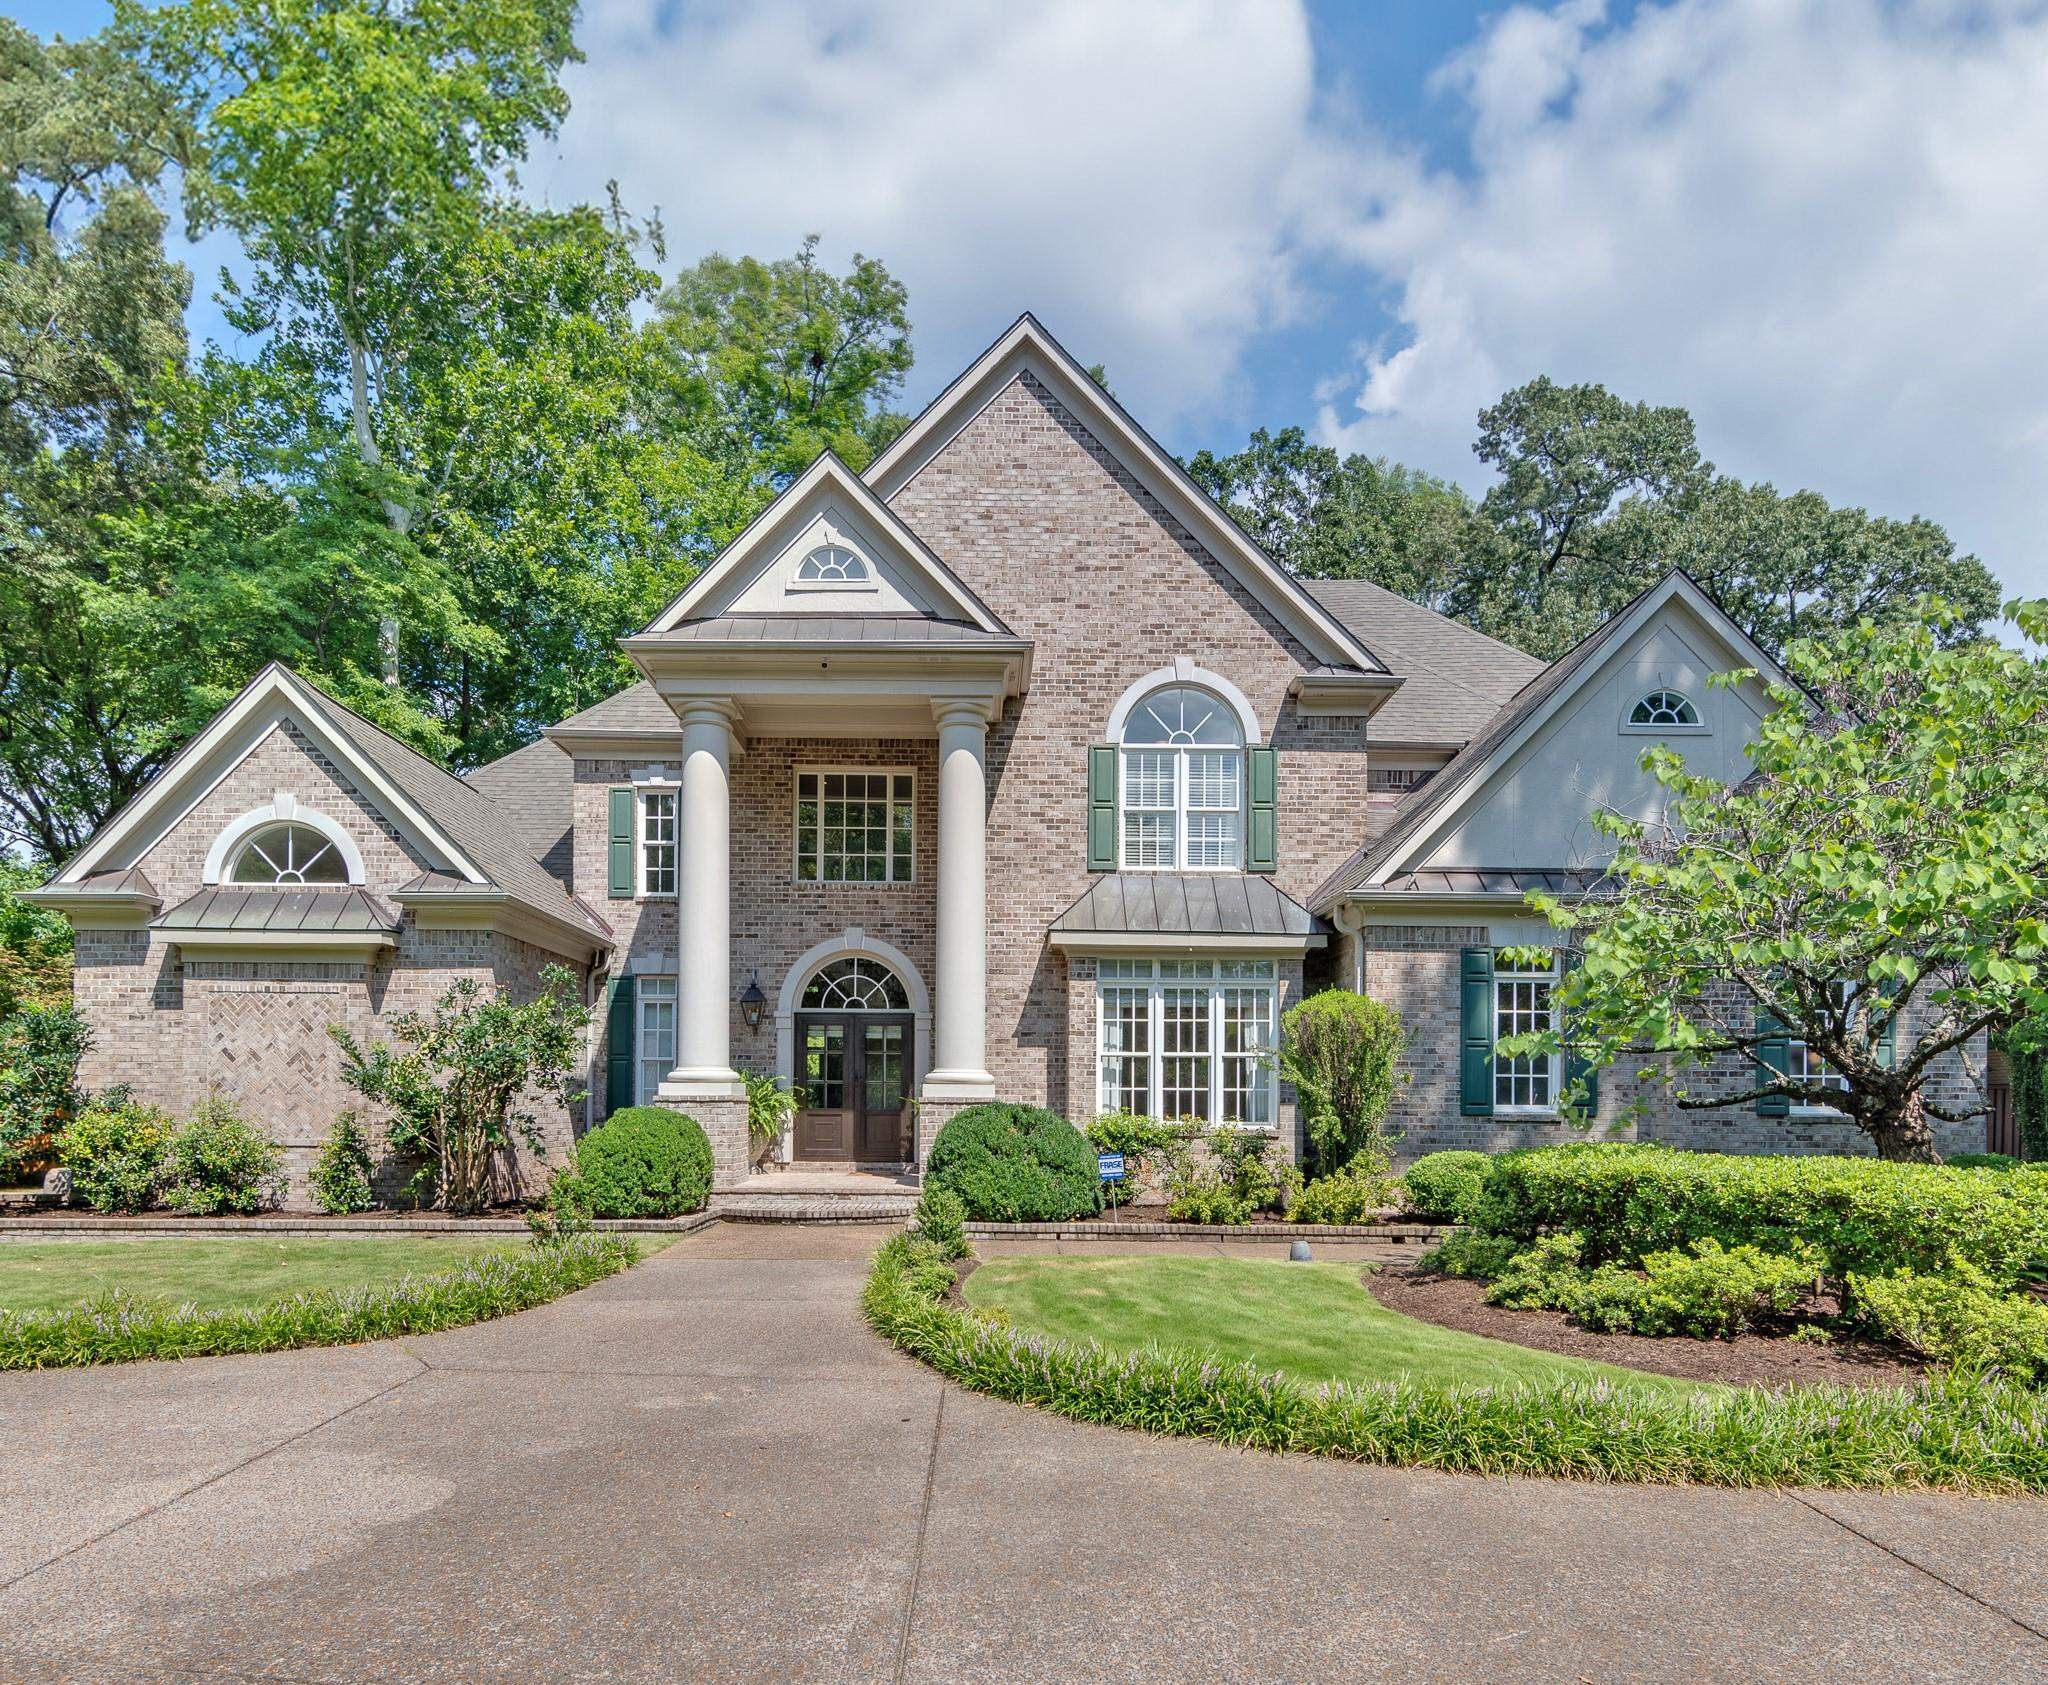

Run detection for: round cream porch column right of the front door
[[924, 698, 995, 1099]]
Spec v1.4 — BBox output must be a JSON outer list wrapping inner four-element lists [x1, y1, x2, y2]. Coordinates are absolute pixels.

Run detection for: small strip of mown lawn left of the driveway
[[0, 1235, 526, 1310]]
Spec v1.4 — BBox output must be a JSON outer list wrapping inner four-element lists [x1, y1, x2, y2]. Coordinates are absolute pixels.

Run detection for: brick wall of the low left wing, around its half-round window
[[74, 723, 584, 1206]]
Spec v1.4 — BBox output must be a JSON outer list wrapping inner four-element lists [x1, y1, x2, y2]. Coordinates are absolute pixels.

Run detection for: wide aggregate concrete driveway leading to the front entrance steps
[[0, 1226, 2048, 1683]]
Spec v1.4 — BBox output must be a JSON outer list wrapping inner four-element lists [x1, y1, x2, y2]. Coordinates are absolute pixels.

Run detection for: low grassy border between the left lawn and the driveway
[[0, 1235, 639, 1370]]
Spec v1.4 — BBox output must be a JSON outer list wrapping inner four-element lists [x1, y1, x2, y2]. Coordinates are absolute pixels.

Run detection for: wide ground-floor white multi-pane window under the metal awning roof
[[1096, 960, 1278, 1128]]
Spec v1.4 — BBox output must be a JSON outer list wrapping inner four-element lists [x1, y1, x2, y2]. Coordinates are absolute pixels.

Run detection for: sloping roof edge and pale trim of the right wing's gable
[[1309, 567, 1784, 911]]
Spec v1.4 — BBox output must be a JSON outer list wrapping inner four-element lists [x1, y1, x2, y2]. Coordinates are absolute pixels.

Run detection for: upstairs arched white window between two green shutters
[[1120, 686, 1245, 870]]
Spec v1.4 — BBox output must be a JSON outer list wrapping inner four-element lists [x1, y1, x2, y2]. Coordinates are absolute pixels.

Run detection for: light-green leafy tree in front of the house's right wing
[[1531, 602, 2048, 1161]]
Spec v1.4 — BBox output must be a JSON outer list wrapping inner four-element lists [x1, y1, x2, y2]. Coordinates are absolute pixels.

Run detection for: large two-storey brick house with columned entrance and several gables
[[37, 315, 1964, 1190]]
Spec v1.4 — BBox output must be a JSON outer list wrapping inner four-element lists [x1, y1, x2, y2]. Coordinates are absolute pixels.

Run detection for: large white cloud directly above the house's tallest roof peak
[[530, 0, 1343, 424]]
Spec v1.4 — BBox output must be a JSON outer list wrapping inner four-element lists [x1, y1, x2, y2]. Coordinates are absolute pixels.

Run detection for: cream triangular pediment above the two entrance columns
[[647, 450, 1008, 633]]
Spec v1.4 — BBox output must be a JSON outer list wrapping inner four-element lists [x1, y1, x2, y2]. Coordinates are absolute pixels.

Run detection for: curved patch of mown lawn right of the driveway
[[967, 1257, 1696, 1392]]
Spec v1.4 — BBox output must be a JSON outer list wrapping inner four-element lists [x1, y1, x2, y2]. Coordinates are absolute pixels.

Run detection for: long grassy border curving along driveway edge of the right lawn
[[862, 1237, 2048, 1493]]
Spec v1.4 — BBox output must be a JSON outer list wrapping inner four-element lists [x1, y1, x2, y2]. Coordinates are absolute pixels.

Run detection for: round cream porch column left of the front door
[[662, 700, 745, 1099]]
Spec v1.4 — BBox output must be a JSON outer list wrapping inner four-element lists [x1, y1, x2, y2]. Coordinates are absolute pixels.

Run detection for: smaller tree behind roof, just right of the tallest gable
[[1188, 428, 1493, 608]]
